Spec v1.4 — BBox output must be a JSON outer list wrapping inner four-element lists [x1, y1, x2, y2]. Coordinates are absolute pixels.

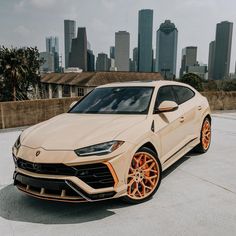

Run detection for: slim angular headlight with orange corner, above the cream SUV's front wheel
[[75, 141, 124, 156]]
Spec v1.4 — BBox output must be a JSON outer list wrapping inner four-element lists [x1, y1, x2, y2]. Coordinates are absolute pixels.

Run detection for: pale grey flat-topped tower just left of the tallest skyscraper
[[115, 31, 130, 71]]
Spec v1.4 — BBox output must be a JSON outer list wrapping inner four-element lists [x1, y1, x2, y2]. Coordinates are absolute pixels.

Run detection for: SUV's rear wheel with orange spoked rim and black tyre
[[195, 117, 211, 153]]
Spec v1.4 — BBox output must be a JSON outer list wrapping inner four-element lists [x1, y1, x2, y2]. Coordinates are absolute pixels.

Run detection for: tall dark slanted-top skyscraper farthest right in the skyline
[[213, 21, 233, 80]]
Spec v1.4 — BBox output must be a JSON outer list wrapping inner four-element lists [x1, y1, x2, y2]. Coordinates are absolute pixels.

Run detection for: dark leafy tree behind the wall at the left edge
[[0, 47, 42, 101]]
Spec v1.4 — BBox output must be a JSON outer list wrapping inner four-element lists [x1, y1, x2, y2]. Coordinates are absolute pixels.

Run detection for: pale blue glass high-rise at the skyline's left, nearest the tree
[[46, 36, 59, 72]]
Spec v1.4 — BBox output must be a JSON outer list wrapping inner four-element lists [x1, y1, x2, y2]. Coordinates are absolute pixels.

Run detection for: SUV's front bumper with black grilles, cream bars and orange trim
[[14, 154, 131, 202]]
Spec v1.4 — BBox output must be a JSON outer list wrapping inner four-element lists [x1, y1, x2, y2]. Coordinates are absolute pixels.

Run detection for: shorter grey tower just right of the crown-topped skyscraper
[[180, 46, 197, 78]]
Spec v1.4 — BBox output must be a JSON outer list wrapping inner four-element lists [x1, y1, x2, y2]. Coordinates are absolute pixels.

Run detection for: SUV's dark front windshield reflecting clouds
[[70, 87, 154, 114]]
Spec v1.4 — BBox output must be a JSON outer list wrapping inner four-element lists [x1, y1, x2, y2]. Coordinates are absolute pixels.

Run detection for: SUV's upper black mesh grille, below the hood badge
[[17, 158, 115, 189]]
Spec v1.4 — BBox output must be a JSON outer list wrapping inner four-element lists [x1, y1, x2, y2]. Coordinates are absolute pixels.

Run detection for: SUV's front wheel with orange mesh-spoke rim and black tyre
[[122, 147, 162, 204]]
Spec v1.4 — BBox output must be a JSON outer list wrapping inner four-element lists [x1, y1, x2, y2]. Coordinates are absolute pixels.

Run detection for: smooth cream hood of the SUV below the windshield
[[21, 113, 147, 150]]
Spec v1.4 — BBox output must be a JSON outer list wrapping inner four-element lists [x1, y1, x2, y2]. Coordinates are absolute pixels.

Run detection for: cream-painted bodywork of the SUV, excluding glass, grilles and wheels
[[13, 81, 210, 200]]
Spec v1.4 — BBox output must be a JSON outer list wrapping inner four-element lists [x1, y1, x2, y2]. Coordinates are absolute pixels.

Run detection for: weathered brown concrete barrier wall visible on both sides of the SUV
[[0, 92, 236, 129]]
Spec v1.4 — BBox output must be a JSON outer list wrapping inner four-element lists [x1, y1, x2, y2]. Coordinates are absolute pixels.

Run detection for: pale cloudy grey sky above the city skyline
[[0, 0, 236, 74]]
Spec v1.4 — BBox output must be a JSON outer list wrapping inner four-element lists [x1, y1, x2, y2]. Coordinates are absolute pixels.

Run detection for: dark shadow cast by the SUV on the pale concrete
[[0, 153, 193, 224]]
